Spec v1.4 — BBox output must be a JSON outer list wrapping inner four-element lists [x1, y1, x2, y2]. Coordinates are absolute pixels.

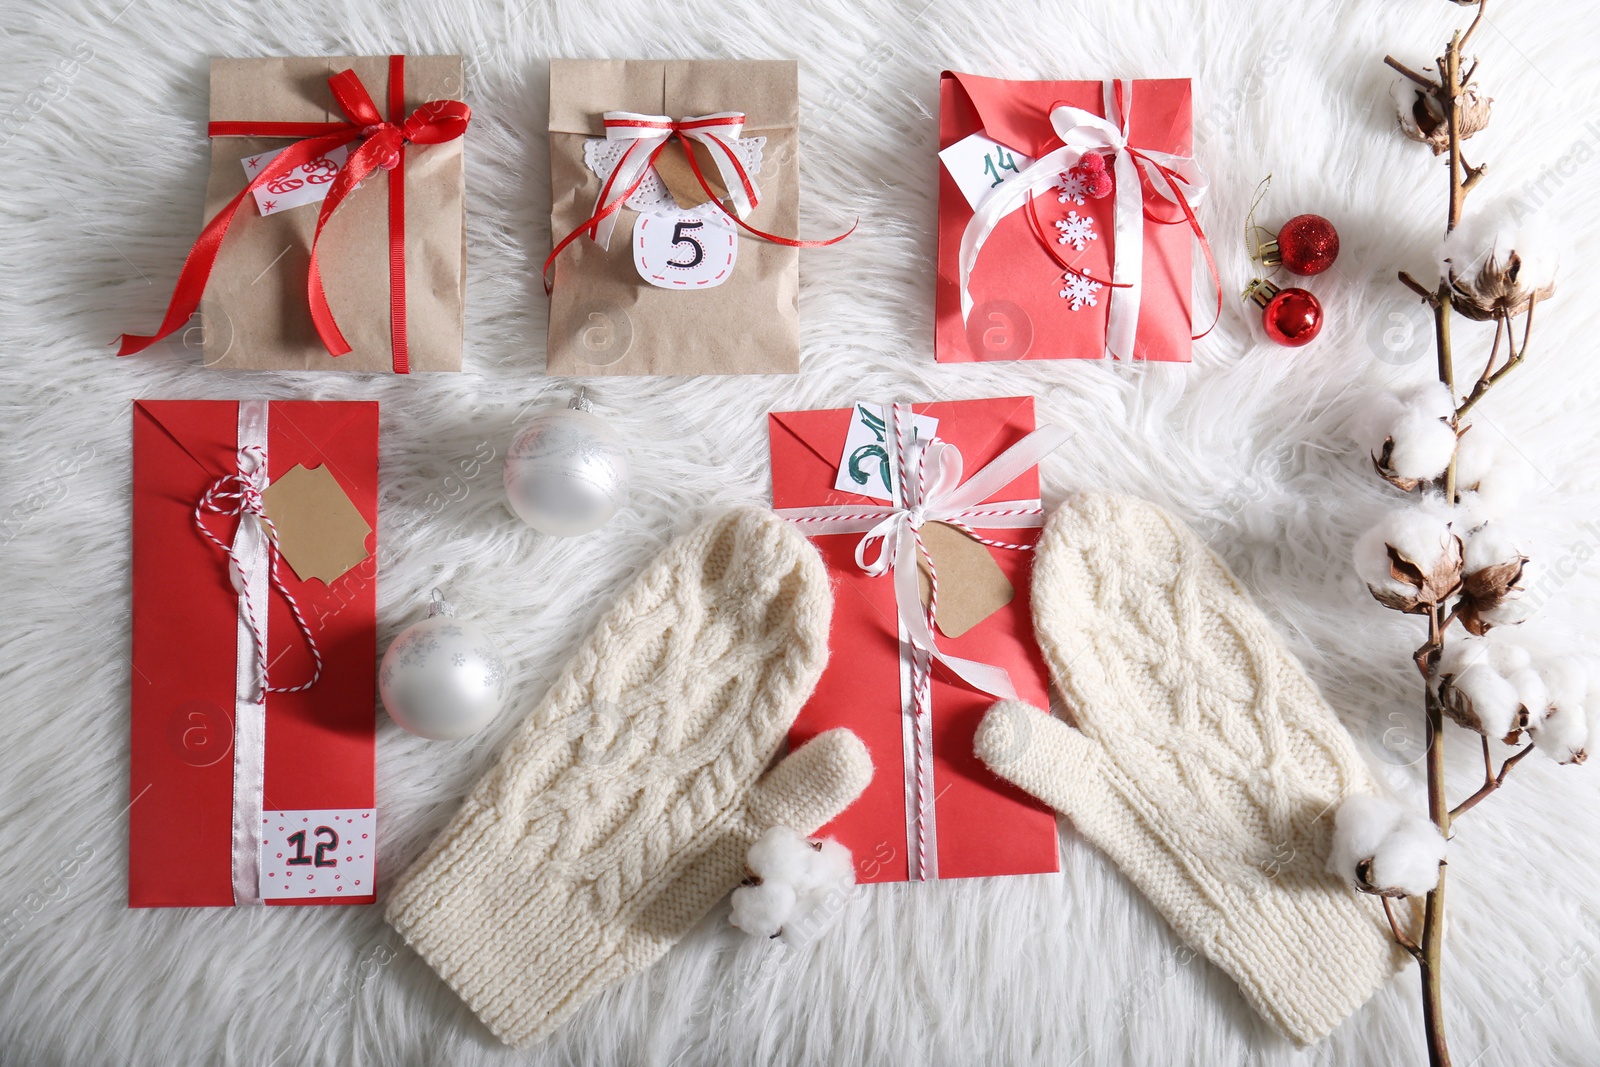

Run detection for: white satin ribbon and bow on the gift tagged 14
[[960, 80, 1206, 360]]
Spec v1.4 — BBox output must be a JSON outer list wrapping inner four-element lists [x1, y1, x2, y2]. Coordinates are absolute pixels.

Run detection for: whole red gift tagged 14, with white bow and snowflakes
[[934, 70, 1221, 362]]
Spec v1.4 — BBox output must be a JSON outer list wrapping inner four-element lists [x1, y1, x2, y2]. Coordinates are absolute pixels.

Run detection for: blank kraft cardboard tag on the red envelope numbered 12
[[261, 466, 374, 585]]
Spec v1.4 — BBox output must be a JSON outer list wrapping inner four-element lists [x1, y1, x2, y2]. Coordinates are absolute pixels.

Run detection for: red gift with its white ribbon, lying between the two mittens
[[768, 397, 1066, 881]]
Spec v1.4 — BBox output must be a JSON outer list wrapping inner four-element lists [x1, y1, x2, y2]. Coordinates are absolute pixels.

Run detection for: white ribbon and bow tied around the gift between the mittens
[[778, 403, 1070, 880]]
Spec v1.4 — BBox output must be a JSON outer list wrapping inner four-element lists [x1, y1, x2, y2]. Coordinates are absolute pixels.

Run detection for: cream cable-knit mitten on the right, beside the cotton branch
[[974, 494, 1405, 1045]]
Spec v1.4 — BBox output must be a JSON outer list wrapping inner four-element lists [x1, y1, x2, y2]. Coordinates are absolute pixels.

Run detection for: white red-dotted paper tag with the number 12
[[261, 808, 378, 901]]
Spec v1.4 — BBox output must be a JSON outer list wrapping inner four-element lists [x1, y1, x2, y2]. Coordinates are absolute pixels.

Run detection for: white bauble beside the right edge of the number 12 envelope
[[378, 601, 507, 741]]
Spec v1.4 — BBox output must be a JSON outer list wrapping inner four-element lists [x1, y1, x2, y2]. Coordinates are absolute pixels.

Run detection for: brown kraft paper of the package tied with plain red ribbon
[[200, 56, 467, 371]]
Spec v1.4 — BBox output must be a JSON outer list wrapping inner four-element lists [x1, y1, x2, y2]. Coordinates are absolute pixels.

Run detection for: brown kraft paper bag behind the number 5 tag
[[546, 59, 800, 376]]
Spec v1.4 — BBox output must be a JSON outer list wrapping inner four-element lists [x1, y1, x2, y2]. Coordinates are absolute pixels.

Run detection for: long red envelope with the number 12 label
[[128, 400, 378, 907]]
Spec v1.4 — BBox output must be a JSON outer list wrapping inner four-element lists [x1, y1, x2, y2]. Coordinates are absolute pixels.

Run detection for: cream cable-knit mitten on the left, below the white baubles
[[387, 509, 872, 1045]]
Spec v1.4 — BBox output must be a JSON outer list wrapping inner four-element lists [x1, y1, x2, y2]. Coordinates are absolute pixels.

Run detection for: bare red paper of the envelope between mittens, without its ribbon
[[768, 397, 1059, 881]]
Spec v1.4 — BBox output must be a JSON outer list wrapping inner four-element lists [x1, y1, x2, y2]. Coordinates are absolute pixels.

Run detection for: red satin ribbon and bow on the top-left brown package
[[117, 56, 472, 374]]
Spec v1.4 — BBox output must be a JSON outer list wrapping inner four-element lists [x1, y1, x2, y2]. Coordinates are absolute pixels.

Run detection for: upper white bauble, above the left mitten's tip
[[506, 398, 627, 537]]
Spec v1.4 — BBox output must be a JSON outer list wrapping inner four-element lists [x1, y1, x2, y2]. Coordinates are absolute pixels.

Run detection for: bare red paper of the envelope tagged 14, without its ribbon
[[934, 70, 1194, 363]]
